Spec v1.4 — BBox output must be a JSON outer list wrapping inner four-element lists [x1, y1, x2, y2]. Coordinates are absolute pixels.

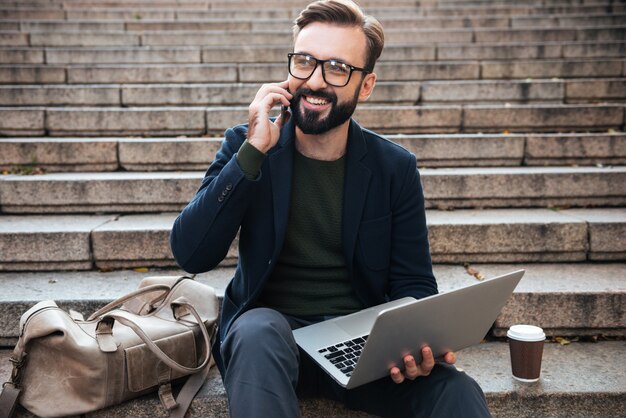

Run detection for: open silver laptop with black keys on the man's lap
[[293, 270, 524, 389]]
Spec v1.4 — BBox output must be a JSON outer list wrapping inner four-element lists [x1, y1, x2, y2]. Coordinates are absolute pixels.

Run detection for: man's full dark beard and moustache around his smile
[[291, 87, 360, 135]]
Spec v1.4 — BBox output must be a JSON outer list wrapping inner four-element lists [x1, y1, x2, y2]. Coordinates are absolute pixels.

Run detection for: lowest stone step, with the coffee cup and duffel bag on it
[[0, 324, 626, 418]]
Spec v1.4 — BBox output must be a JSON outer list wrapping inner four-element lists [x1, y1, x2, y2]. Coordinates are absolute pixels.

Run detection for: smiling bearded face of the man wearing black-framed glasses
[[289, 23, 376, 135]]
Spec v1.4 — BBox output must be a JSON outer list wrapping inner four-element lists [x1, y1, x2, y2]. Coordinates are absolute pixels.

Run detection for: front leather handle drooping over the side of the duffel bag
[[96, 296, 215, 374]]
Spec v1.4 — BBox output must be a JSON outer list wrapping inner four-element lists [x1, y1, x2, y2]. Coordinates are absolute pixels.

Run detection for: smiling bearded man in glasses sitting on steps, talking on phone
[[171, 0, 489, 418]]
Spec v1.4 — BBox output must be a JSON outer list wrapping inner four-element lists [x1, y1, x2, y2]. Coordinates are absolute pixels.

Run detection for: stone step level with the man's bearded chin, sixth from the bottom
[[0, 103, 624, 136]]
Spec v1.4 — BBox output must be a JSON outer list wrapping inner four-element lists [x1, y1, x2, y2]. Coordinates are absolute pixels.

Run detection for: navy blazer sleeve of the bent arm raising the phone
[[170, 125, 261, 273]]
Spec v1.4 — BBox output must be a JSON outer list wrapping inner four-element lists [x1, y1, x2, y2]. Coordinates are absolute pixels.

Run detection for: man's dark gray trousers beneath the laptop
[[221, 308, 491, 418]]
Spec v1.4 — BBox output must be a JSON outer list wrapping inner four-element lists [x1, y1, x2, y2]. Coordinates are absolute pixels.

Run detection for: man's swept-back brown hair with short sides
[[293, 0, 385, 71]]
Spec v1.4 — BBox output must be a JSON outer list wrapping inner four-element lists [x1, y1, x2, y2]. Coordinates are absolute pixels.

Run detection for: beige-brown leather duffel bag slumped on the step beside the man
[[0, 276, 219, 417]]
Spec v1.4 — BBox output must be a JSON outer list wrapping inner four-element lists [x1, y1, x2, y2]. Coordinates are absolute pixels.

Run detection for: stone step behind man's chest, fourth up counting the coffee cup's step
[[0, 166, 626, 214]]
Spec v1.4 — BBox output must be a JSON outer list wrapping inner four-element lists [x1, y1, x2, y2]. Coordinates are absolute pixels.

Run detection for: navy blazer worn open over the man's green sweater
[[170, 119, 437, 372]]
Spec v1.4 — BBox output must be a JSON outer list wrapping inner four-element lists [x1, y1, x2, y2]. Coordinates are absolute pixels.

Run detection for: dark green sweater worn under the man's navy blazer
[[238, 144, 361, 316]]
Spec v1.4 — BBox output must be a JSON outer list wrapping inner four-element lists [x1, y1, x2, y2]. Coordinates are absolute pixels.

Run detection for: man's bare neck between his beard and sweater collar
[[295, 120, 350, 161]]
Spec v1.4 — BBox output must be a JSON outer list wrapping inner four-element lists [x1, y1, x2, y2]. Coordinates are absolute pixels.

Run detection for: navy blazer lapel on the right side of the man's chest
[[342, 121, 371, 271]]
